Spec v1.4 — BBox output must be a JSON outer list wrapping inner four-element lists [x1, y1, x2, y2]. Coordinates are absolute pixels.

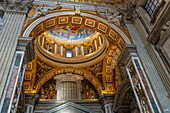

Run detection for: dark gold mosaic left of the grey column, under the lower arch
[[39, 78, 57, 99]]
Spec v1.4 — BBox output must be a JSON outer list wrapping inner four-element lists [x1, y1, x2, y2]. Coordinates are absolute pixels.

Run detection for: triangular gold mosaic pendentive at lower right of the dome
[[85, 61, 103, 83]]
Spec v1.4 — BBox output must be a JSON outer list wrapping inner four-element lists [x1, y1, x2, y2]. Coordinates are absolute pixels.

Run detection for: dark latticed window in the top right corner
[[145, 0, 162, 17]]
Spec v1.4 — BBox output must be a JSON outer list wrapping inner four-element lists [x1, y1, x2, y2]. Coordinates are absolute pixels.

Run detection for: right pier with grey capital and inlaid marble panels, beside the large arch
[[118, 44, 161, 113]]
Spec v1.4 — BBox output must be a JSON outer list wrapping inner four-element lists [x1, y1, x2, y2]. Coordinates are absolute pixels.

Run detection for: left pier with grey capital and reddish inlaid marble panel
[[0, 38, 34, 113]]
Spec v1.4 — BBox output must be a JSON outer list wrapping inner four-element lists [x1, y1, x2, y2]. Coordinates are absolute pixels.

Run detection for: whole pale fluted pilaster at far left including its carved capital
[[0, 1, 33, 102]]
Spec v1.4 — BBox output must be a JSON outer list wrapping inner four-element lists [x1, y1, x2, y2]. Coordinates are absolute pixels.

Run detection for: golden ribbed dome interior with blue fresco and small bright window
[[36, 26, 108, 67]]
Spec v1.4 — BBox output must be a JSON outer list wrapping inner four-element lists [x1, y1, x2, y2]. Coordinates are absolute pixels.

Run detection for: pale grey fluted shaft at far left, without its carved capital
[[0, 13, 26, 101]]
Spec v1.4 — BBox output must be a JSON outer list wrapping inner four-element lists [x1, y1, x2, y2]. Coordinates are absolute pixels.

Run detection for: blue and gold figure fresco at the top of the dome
[[47, 26, 95, 40]]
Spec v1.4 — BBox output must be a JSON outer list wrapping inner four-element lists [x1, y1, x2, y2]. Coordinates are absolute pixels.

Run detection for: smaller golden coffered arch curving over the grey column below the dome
[[35, 67, 103, 95]]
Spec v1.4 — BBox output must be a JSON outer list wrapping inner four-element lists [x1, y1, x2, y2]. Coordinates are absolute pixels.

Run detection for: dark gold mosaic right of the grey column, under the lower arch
[[81, 79, 99, 99]]
